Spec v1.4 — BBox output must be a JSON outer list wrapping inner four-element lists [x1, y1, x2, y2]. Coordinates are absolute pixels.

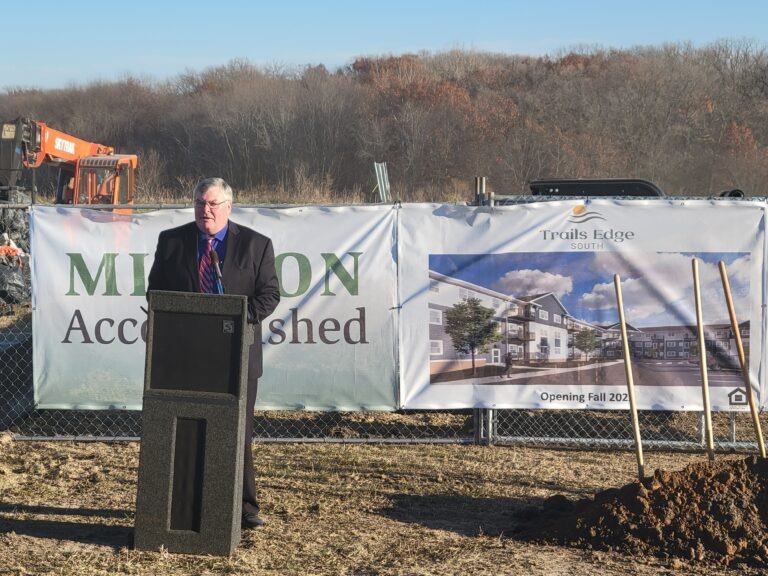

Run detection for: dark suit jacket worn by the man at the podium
[[147, 220, 280, 380]]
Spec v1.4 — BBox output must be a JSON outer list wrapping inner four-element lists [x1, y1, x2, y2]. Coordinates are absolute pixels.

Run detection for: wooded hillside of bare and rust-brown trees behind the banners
[[0, 41, 768, 202]]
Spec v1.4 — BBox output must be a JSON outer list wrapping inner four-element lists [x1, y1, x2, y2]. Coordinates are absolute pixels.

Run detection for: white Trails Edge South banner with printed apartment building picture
[[398, 199, 766, 410]]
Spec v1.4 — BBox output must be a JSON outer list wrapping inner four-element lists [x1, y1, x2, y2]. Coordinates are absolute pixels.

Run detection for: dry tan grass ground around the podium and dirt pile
[[0, 434, 760, 576]]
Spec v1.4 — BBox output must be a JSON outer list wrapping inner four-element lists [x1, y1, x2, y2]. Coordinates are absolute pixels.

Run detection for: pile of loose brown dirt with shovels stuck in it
[[515, 457, 768, 567]]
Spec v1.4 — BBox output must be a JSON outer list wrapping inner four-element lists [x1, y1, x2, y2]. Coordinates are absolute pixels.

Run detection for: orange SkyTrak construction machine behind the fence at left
[[0, 118, 138, 205]]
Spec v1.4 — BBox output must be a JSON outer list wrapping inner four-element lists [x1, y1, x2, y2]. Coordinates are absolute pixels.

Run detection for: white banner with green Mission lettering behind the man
[[30, 206, 397, 410]]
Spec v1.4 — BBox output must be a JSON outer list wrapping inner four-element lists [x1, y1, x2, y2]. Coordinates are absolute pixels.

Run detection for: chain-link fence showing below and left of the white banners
[[0, 202, 768, 450]]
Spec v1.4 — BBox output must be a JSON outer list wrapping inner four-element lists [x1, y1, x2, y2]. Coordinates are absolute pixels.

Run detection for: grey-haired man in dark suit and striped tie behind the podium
[[147, 178, 280, 528]]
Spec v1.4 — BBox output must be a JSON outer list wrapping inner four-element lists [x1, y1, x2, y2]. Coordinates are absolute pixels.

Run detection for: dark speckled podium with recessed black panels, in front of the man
[[134, 291, 253, 555]]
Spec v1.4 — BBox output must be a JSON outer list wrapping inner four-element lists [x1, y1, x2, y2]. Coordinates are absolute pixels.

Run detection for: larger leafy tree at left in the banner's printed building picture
[[445, 298, 501, 376]]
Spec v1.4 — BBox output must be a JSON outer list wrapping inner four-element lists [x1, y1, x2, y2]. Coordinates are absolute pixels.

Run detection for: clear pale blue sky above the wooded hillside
[[0, 0, 768, 89]]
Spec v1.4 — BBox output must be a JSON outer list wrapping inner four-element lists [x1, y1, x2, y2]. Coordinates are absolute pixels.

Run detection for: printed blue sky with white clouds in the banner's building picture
[[429, 252, 751, 328]]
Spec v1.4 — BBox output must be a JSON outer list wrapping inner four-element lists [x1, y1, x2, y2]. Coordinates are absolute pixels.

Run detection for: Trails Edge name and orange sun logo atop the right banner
[[539, 204, 636, 250]]
